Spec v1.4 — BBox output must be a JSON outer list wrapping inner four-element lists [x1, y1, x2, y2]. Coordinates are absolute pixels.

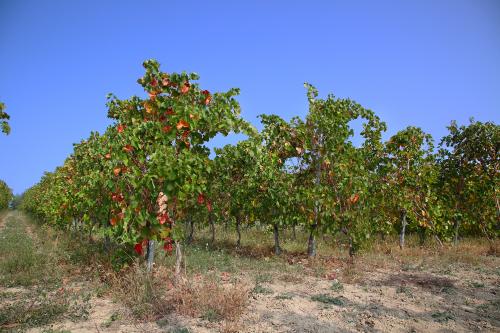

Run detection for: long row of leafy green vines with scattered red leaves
[[13, 60, 500, 270]]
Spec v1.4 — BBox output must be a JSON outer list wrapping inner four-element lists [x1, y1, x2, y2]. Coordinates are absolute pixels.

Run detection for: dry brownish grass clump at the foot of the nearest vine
[[109, 265, 249, 322]]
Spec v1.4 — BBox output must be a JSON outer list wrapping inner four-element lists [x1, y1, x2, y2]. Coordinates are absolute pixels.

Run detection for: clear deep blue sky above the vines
[[0, 0, 500, 193]]
